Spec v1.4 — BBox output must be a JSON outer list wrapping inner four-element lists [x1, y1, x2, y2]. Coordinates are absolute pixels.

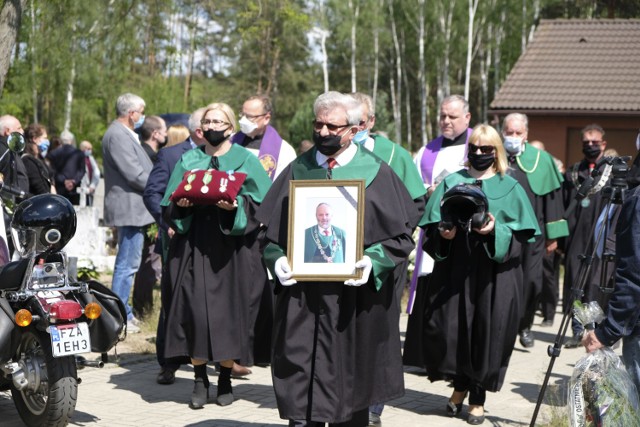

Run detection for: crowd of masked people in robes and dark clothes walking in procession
[[0, 92, 640, 426]]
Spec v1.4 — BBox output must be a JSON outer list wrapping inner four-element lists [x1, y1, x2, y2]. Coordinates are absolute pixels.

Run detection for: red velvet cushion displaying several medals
[[169, 169, 247, 205]]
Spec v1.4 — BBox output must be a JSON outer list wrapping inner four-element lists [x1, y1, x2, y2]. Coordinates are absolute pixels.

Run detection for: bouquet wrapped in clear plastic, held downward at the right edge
[[568, 302, 640, 427]]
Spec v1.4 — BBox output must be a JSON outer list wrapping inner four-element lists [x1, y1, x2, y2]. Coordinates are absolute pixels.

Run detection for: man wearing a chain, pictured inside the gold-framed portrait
[[304, 202, 345, 264]]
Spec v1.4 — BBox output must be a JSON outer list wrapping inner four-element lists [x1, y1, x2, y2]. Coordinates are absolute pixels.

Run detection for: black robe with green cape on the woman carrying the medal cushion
[[162, 145, 271, 364]]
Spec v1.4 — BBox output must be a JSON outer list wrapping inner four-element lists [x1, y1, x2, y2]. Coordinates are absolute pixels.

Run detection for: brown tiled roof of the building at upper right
[[491, 19, 640, 111]]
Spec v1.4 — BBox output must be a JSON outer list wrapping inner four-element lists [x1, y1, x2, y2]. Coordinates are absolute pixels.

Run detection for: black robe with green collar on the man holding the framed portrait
[[257, 148, 419, 423]]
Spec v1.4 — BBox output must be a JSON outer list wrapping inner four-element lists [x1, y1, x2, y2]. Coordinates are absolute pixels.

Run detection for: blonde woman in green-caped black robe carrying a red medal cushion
[[161, 103, 271, 409]]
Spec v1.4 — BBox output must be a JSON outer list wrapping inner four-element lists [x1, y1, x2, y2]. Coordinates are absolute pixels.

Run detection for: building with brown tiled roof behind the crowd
[[489, 19, 640, 165]]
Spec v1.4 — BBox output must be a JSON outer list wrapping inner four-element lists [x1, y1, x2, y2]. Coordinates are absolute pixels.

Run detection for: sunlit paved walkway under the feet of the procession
[[0, 316, 584, 427]]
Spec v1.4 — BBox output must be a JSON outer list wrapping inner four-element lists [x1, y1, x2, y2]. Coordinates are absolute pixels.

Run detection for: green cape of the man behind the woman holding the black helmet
[[516, 143, 564, 196]]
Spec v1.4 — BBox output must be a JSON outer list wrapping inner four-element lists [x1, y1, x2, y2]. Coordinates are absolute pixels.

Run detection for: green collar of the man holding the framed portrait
[[292, 144, 382, 187]]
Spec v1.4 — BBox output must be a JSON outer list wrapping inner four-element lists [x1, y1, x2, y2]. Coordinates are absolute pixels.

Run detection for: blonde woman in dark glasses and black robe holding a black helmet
[[422, 125, 539, 424]]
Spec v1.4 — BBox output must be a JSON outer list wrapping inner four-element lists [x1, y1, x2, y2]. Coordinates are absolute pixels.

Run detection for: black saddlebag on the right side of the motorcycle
[[77, 280, 127, 353]]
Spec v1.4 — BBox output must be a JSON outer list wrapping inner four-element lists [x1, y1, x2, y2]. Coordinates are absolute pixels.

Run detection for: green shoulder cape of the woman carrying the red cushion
[[160, 144, 271, 206]]
